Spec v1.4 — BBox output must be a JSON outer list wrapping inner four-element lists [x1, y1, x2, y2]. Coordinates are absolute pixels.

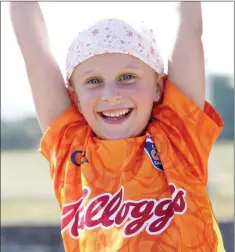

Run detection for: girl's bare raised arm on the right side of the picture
[[168, 2, 205, 108]]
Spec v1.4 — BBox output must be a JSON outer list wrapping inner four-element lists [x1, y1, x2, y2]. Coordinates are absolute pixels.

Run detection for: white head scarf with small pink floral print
[[66, 19, 164, 79]]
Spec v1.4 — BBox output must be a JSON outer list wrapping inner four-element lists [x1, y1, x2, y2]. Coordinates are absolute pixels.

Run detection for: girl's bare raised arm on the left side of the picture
[[10, 2, 70, 132]]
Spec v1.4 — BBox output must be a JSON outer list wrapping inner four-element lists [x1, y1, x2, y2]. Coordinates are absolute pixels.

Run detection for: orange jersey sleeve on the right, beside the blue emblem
[[153, 80, 224, 179]]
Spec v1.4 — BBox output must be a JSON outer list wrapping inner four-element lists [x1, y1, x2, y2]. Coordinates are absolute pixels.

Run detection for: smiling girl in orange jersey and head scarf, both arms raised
[[11, 2, 224, 252]]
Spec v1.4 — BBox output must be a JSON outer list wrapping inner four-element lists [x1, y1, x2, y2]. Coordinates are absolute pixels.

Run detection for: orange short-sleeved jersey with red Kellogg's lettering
[[40, 81, 225, 252]]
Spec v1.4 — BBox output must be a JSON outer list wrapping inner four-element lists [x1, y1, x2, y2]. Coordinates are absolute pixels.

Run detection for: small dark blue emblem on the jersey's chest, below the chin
[[144, 134, 164, 171]]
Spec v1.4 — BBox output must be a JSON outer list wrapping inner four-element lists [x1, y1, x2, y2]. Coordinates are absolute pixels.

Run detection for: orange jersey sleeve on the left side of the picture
[[39, 106, 87, 180]]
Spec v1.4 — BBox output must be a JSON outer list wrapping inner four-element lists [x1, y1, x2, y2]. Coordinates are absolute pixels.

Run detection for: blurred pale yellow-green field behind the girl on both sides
[[1, 142, 234, 225]]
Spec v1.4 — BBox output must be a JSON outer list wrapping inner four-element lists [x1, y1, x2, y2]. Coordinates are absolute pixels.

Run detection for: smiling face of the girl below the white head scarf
[[71, 53, 163, 139]]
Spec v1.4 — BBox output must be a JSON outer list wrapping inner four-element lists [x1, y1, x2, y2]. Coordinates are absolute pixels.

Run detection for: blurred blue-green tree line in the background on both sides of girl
[[1, 75, 234, 150]]
